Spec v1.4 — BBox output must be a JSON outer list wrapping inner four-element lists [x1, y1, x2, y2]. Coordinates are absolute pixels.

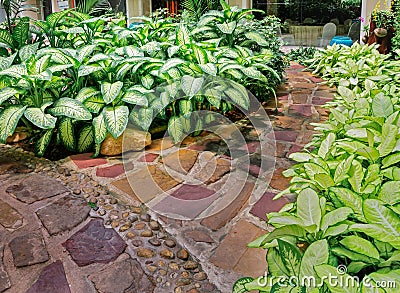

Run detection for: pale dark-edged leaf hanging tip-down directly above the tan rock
[[103, 106, 129, 138]]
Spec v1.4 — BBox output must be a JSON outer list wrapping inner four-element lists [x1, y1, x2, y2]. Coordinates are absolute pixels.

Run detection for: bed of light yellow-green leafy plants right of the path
[[234, 45, 400, 292]]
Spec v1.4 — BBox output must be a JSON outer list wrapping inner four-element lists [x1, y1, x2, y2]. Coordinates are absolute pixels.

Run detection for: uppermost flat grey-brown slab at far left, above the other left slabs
[[6, 174, 68, 203]]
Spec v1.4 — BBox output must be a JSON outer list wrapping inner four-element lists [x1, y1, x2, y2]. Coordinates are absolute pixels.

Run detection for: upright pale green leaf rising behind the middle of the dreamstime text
[[299, 239, 329, 284]]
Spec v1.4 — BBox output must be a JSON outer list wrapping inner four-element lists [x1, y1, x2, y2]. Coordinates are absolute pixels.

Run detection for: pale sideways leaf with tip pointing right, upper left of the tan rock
[[49, 98, 92, 120]]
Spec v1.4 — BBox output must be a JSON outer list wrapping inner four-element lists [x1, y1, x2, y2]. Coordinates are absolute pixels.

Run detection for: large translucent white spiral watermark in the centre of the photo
[[123, 76, 275, 220]]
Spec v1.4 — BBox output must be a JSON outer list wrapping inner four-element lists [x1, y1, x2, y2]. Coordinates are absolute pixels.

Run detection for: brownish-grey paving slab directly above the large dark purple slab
[[36, 194, 90, 235]]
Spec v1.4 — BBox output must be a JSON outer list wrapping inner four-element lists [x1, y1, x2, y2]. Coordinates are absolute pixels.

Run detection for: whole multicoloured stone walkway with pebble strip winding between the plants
[[0, 64, 334, 293]]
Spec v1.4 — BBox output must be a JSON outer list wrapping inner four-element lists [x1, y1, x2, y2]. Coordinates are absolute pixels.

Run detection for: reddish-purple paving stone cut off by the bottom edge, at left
[[26, 260, 71, 293]]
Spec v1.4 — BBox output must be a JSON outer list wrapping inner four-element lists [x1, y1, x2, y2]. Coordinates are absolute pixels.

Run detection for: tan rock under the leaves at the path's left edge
[[100, 128, 151, 156]]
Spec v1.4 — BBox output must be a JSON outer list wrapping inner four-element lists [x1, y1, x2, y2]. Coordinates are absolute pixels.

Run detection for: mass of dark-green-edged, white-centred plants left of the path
[[0, 1, 285, 156]]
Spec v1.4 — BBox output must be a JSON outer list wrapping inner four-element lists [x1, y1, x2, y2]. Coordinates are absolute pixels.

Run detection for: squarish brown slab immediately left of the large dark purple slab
[[9, 231, 49, 267]]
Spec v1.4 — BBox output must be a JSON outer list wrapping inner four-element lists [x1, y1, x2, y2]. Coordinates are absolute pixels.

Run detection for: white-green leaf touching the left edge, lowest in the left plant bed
[[0, 105, 27, 143]]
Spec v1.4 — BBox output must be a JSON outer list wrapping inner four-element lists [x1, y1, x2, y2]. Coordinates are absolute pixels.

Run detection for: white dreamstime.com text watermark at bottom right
[[257, 265, 400, 289]]
